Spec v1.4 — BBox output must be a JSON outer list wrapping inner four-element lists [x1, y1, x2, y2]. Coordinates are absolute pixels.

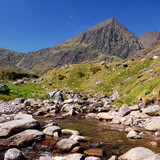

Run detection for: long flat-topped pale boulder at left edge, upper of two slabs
[[0, 115, 39, 137]]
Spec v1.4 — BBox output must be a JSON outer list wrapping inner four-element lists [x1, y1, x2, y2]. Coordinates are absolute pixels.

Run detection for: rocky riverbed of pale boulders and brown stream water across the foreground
[[0, 90, 160, 160]]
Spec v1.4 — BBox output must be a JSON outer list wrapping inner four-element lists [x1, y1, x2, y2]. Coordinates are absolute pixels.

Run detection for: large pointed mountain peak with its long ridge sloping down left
[[16, 18, 144, 74]]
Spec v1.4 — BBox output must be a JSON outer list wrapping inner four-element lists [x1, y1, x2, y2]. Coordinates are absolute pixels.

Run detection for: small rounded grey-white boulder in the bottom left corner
[[4, 148, 25, 160]]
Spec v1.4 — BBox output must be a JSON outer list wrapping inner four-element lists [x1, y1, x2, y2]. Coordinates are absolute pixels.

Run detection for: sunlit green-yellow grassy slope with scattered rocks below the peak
[[42, 58, 160, 106]]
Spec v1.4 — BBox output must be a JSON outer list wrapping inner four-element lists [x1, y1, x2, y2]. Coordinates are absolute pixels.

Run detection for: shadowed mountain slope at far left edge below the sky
[[0, 47, 24, 70]]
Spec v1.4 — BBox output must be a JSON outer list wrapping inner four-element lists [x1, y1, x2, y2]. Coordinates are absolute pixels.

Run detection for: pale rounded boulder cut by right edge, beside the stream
[[145, 116, 160, 131]]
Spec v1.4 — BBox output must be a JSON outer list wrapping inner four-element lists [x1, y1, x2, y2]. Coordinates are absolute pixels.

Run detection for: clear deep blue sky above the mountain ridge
[[0, 0, 160, 52]]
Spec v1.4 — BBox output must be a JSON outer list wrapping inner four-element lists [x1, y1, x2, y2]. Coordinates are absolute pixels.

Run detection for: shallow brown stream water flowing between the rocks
[[22, 117, 160, 160]]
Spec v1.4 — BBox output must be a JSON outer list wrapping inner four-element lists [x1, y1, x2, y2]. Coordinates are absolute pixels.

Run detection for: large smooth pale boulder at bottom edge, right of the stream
[[118, 147, 155, 160]]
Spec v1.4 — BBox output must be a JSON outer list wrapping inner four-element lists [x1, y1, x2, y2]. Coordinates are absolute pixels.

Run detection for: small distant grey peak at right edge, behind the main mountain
[[140, 31, 160, 48]]
